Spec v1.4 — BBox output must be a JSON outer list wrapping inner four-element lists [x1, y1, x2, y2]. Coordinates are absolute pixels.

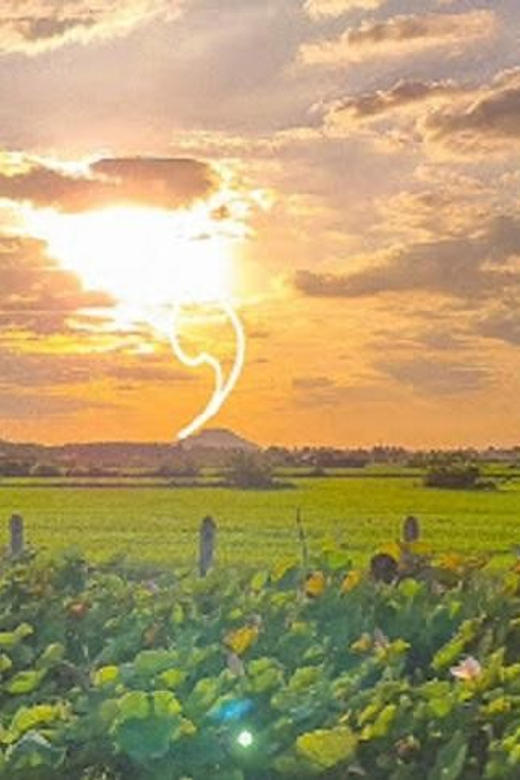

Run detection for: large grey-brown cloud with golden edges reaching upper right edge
[[316, 68, 520, 159]]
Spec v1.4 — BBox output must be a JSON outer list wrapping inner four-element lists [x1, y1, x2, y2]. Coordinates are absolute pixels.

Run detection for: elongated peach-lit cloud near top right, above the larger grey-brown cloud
[[300, 10, 498, 67]]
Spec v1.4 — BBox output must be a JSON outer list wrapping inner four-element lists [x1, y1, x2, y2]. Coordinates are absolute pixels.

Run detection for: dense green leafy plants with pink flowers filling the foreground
[[0, 543, 520, 780]]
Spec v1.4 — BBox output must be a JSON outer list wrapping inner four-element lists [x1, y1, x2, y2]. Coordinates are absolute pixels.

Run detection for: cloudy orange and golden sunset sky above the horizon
[[0, 0, 520, 447]]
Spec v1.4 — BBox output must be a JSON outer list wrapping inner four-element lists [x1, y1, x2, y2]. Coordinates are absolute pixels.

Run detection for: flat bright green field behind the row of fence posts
[[0, 476, 520, 566]]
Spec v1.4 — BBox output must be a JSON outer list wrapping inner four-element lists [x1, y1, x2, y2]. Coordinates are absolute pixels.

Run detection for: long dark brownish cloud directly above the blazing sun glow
[[0, 157, 218, 213]]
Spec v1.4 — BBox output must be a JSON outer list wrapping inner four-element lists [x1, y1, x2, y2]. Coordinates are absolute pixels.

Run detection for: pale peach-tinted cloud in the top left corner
[[0, 0, 182, 54]]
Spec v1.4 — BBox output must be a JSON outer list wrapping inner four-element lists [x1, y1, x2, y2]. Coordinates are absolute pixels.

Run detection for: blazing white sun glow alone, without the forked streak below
[[28, 207, 233, 308]]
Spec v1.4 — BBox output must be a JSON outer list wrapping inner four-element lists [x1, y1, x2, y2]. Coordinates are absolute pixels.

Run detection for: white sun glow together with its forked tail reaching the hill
[[28, 201, 245, 439]]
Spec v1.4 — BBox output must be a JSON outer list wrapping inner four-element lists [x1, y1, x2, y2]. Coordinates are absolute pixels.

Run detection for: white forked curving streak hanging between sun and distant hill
[[170, 301, 246, 441]]
